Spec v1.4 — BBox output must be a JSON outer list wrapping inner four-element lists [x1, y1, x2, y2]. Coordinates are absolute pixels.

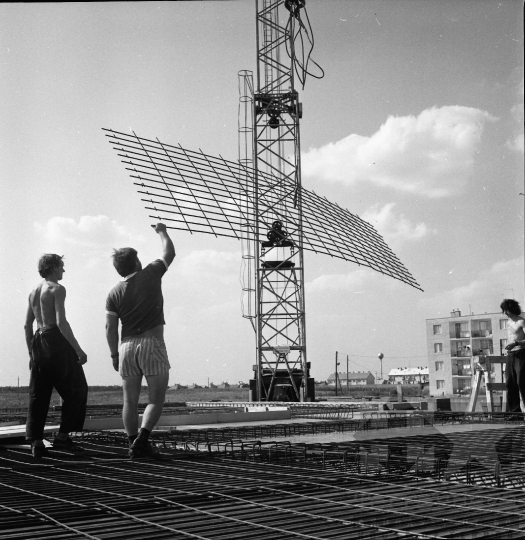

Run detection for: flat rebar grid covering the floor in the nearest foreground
[[0, 437, 525, 540]]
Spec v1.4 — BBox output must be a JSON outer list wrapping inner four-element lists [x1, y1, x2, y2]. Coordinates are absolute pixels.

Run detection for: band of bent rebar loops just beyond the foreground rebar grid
[[83, 425, 525, 489]]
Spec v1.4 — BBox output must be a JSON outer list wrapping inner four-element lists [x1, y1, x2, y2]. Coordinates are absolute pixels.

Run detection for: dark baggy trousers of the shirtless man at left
[[26, 326, 88, 441]]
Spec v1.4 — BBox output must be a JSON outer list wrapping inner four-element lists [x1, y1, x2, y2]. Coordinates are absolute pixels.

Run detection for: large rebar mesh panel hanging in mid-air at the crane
[[104, 129, 422, 290]]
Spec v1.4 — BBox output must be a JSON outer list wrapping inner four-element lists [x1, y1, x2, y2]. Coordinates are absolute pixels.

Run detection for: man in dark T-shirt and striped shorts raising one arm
[[106, 223, 175, 459]]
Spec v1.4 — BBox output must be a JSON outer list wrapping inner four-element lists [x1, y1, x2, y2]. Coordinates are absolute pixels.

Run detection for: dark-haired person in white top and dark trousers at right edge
[[500, 299, 525, 413]]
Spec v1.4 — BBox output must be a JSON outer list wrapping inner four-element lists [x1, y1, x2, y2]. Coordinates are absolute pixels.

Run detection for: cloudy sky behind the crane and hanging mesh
[[0, 0, 525, 386]]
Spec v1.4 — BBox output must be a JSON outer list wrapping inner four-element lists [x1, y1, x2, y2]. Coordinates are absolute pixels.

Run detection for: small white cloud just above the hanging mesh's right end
[[362, 203, 436, 249]]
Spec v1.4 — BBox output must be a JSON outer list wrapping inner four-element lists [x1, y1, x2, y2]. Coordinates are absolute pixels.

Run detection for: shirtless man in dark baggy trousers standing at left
[[24, 254, 88, 460]]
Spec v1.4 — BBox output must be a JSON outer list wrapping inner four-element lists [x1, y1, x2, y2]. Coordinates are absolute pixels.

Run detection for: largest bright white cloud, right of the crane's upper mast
[[302, 106, 497, 197]]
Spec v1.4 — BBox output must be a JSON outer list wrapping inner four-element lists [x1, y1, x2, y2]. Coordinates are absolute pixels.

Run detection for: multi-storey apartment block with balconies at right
[[426, 310, 507, 396]]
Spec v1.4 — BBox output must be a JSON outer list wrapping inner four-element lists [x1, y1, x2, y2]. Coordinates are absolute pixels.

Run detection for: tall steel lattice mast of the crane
[[249, 0, 309, 401]]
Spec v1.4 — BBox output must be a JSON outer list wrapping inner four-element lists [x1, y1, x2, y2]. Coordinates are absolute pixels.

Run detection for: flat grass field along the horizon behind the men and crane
[[0, 385, 428, 409]]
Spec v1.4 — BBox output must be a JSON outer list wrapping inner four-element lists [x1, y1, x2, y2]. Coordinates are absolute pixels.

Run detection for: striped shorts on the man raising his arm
[[119, 337, 170, 377]]
